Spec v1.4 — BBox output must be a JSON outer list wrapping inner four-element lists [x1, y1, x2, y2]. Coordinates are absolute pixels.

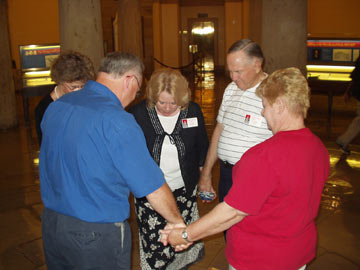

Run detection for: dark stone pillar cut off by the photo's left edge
[[0, 0, 17, 129]]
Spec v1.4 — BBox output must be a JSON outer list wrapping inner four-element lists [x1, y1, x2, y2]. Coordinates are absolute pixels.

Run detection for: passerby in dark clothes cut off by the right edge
[[336, 56, 360, 155]]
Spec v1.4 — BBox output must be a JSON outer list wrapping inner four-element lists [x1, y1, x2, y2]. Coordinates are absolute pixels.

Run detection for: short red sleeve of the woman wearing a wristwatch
[[224, 148, 277, 215]]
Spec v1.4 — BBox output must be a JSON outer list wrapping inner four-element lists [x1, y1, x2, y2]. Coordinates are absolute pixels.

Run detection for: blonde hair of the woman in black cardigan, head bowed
[[146, 68, 191, 109]]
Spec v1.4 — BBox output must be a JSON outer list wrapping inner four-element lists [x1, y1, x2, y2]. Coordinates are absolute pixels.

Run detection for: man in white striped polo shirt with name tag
[[199, 39, 272, 207]]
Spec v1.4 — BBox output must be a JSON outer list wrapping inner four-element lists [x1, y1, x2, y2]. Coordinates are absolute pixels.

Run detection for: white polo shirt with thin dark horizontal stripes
[[216, 82, 272, 164]]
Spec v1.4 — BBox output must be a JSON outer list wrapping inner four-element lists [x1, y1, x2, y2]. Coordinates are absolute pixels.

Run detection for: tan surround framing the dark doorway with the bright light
[[180, 6, 225, 69]]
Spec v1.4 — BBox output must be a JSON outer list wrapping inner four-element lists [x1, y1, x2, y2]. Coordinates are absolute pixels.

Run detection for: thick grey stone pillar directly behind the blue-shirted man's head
[[59, 0, 104, 70]]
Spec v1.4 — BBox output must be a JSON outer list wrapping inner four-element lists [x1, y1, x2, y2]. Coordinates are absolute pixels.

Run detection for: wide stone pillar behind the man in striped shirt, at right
[[249, 0, 307, 74]]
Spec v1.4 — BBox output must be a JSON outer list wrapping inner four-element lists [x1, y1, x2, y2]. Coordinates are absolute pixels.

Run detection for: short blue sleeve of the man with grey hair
[[106, 114, 165, 198]]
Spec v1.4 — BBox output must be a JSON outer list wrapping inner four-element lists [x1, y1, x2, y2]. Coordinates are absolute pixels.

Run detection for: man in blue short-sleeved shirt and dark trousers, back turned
[[40, 52, 185, 270]]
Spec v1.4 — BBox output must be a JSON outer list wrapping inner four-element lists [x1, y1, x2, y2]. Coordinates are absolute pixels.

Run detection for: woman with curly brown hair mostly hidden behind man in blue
[[35, 51, 95, 145]]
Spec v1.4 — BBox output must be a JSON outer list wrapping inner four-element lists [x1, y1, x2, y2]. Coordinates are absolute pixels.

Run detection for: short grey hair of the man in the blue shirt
[[99, 52, 144, 77]]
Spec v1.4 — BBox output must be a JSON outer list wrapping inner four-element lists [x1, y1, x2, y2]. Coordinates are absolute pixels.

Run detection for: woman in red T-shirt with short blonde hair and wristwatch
[[161, 68, 330, 270]]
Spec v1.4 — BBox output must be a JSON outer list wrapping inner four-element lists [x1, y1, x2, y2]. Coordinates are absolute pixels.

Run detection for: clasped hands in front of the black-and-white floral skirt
[[160, 223, 193, 252]]
